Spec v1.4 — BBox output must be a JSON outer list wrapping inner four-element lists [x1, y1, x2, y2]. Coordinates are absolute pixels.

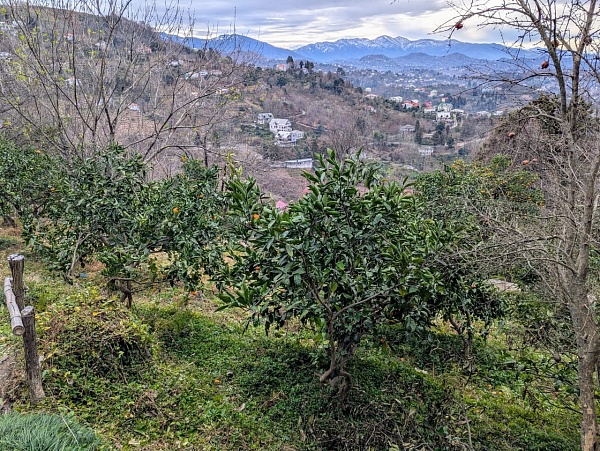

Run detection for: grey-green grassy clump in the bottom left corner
[[0, 413, 101, 451]]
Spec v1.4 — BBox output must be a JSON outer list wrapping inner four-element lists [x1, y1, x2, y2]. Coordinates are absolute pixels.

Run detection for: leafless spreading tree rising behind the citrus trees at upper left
[[0, 0, 251, 165]]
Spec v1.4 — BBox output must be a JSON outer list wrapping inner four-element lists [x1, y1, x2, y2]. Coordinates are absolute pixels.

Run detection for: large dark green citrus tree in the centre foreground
[[219, 151, 480, 397]]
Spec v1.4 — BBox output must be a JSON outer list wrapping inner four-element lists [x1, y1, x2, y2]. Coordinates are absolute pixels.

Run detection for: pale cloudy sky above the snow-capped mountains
[[192, 0, 500, 49]]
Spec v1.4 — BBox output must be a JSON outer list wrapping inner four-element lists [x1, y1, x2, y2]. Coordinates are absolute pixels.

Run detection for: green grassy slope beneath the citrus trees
[[0, 231, 578, 451]]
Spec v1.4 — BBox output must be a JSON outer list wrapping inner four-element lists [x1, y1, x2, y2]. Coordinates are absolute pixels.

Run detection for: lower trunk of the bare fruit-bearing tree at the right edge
[[569, 282, 600, 451]]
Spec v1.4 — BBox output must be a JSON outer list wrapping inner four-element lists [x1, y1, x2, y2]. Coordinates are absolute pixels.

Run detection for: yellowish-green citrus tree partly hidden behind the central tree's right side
[[414, 155, 544, 357]]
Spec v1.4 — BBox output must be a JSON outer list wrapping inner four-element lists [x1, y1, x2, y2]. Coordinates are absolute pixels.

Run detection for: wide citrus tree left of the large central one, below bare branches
[[26, 147, 225, 305]]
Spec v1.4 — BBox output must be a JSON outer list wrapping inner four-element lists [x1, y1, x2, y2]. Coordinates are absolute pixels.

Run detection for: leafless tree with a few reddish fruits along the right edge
[[422, 0, 600, 451]]
